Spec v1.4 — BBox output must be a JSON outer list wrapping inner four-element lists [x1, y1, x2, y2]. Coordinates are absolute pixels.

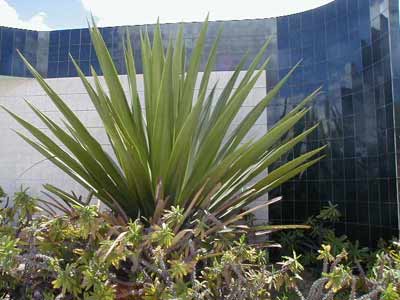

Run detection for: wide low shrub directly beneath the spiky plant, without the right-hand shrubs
[[0, 189, 306, 299]]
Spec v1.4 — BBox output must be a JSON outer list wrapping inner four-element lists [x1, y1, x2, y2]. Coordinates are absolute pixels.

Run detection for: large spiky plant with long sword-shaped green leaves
[[6, 20, 322, 224]]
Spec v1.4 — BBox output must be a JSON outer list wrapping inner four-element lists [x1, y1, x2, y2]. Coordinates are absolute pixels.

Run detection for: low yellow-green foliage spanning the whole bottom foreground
[[0, 190, 400, 300]]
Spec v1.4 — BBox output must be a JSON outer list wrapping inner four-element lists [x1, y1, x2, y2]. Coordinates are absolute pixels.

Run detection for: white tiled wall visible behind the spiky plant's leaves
[[0, 72, 267, 218]]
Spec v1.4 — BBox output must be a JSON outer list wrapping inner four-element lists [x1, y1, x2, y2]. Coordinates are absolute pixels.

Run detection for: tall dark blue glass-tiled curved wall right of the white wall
[[268, 0, 399, 244]]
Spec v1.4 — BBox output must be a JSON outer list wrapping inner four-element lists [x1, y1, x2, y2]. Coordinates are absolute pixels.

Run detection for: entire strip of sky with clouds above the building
[[0, 0, 332, 30]]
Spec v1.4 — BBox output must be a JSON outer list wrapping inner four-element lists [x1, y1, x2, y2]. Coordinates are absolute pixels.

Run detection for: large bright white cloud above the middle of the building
[[81, 0, 332, 26]]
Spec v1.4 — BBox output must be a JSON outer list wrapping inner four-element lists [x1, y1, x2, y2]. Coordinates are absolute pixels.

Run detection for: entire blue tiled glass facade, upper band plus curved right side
[[0, 0, 400, 244]]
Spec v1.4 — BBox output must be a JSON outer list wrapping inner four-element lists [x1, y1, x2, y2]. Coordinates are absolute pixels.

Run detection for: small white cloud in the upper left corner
[[0, 0, 50, 30]]
